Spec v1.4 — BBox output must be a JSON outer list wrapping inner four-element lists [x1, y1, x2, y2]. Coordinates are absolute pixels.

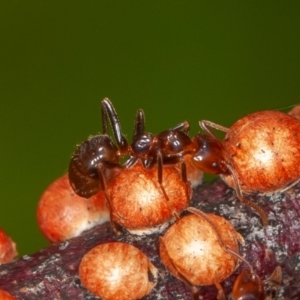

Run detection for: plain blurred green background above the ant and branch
[[0, 0, 300, 254]]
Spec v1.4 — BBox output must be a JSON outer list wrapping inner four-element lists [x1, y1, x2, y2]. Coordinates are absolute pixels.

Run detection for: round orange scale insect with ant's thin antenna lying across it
[[160, 207, 244, 299]]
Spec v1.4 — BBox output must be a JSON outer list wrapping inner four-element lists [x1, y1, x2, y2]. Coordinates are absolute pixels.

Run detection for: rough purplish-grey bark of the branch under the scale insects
[[0, 180, 300, 300]]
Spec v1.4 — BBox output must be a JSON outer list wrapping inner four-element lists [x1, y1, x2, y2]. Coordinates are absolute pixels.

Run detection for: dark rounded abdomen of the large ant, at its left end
[[69, 135, 120, 198]]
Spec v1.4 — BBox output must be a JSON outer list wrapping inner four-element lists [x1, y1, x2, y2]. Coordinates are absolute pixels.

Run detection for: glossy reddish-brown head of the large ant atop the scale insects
[[192, 133, 228, 174]]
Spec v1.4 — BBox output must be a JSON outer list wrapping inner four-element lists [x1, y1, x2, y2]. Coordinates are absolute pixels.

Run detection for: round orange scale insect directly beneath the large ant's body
[[107, 161, 191, 234]]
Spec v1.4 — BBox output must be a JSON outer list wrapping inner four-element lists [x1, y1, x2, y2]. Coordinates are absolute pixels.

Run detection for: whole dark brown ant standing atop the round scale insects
[[69, 98, 267, 225]]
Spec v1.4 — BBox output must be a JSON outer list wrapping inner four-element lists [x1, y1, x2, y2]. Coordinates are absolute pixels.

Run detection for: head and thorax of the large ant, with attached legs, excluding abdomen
[[125, 109, 267, 225]]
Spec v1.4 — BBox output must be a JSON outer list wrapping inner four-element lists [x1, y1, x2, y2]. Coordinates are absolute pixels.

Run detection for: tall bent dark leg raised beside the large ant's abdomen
[[101, 98, 128, 154]]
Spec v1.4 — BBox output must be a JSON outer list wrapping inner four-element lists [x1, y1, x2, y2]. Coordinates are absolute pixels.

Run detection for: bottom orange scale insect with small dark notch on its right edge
[[79, 242, 158, 300]]
